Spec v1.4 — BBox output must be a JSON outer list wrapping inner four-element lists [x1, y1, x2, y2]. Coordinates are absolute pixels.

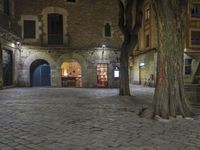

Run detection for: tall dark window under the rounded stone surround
[[48, 13, 63, 45]]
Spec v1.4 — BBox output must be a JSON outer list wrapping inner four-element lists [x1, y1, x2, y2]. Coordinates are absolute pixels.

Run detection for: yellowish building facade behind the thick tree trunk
[[129, 0, 200, 86]]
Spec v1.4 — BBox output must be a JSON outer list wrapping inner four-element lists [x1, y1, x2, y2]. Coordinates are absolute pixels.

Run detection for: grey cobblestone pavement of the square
[[0, 86, 200, 150]]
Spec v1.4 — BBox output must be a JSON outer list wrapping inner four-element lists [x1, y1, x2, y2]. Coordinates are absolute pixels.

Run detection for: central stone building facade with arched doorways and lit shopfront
[[1, 0, 123, 87]]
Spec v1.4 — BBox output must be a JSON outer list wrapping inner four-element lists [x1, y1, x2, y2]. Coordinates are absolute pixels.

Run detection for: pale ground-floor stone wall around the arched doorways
[[18, 46, 119, 87]]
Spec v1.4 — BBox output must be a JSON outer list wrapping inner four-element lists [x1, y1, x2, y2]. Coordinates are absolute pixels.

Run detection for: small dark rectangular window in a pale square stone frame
[[24, 20, 35, 39]]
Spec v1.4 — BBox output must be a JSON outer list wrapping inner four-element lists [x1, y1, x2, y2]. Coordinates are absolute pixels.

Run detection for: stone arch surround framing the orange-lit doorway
[[56, 53, 87, 87]]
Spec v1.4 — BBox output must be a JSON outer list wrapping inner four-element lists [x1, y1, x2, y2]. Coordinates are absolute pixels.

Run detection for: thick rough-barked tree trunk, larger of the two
[[153, 0, 191, 118]]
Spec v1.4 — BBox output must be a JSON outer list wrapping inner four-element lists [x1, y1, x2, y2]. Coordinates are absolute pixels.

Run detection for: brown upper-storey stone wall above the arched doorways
[[15, 0, 122, 49]]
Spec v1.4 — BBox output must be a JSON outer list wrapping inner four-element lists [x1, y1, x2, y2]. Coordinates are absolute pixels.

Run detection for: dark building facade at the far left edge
[[0, 0, 20, 88]]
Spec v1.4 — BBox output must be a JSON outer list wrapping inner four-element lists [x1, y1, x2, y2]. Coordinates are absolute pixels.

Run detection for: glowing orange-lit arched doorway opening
[[61, 60, 82, 87]]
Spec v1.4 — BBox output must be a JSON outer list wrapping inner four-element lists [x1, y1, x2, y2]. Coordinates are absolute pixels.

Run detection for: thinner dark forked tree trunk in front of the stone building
[[118, 0, 143, 96]]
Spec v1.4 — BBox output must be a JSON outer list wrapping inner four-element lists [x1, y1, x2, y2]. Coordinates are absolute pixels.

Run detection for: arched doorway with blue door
[[30, 59, 51, 87]]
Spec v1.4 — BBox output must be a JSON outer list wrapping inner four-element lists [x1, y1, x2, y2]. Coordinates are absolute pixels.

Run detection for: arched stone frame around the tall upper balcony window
[[41, 7, 68, 45]]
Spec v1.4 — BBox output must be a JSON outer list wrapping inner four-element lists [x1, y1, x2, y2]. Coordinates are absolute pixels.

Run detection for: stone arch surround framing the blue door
[[19, 52, 56, 86]]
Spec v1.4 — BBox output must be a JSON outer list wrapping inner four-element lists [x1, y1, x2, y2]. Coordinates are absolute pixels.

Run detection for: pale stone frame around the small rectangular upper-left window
[[19, 15, 41, 42]]
